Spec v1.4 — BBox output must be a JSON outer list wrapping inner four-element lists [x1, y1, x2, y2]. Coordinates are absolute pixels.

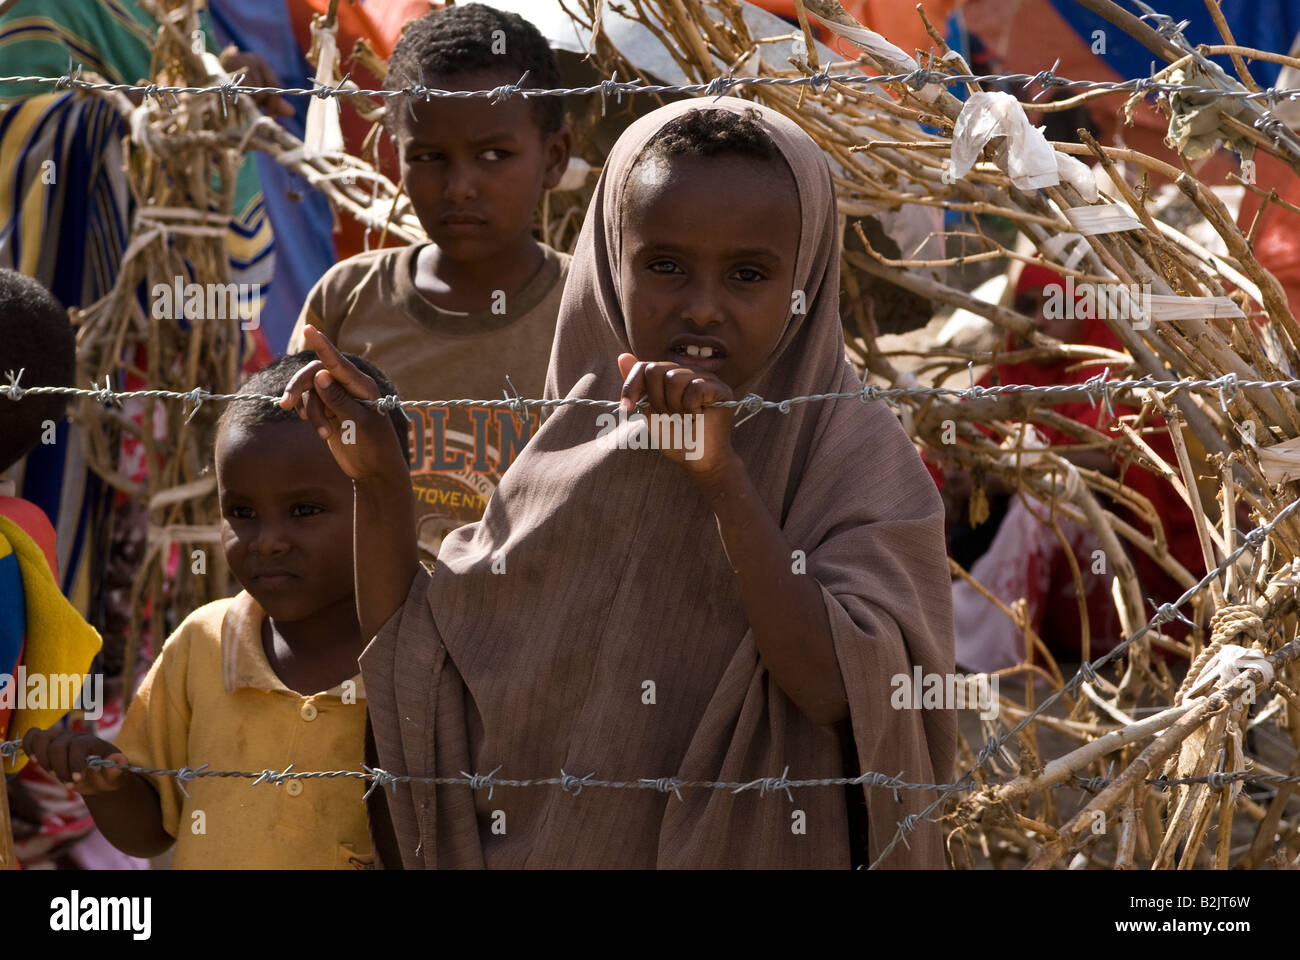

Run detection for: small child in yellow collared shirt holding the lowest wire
[[23, 351, 408, 869]]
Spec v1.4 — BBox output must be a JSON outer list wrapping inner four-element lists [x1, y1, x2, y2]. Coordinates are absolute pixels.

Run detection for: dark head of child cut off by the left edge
[[0, 269, 77, 470]]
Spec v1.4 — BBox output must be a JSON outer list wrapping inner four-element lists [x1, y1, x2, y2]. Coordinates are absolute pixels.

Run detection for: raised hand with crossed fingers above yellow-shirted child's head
[[280, 324, 407, 480]]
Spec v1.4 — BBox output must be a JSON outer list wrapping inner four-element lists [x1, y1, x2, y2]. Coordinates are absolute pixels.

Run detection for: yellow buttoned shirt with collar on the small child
[[116, 592, 374, 870]]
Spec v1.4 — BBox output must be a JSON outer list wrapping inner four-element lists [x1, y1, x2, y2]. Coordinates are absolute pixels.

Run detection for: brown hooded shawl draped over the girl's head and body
[[361, 98, 956, 868]]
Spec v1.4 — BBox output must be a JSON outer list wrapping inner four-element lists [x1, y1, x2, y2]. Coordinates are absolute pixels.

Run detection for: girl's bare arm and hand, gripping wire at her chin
[[619, 354, 849, 725]]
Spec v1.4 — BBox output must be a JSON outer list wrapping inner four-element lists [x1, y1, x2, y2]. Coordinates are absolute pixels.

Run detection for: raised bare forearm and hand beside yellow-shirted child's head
[[281, 325, 420, 637]]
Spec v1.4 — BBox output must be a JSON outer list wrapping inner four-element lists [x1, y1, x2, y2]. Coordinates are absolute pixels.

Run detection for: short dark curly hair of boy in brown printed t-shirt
[[384, 4, 564, 135]]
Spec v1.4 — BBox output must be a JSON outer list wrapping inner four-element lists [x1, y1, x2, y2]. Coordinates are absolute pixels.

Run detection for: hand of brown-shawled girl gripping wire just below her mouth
[[619, 354, 736, 483]]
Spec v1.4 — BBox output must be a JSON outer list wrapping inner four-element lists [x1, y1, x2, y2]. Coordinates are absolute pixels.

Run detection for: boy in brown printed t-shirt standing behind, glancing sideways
[[289, 4, 572, 562]]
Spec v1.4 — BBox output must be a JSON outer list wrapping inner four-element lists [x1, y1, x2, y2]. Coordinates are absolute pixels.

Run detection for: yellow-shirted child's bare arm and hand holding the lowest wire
[[22, 727, 173, 857]]
